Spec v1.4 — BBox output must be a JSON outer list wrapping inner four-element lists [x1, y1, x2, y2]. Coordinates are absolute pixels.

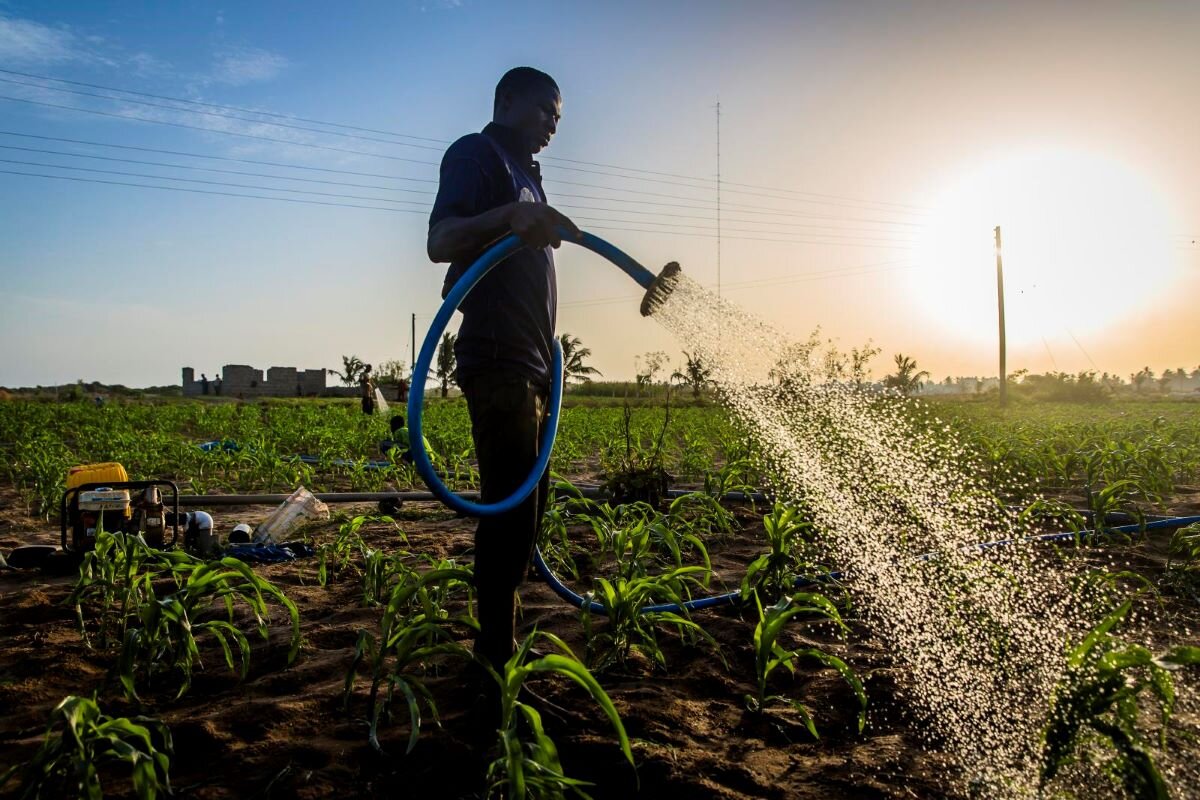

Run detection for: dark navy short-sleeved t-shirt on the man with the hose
[[430, 122, 558, 385]]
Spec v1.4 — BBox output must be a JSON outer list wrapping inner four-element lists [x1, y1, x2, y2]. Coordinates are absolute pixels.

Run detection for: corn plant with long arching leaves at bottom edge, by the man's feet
[[487, 631, 636, 799]]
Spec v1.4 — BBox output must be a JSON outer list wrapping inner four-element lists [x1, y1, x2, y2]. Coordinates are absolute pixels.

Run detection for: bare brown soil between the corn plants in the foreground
[[0, 484, 1198, 798]]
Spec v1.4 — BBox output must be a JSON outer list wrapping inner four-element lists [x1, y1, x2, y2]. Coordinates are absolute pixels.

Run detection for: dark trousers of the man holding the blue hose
[[460, 372, 550, 668]]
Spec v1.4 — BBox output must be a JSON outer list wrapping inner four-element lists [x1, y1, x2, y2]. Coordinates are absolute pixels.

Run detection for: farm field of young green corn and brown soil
[[0, 399, 1200, 798]]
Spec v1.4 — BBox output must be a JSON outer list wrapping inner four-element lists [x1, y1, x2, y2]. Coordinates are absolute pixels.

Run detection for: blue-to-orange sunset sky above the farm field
[[0, 0, 1200, 386]]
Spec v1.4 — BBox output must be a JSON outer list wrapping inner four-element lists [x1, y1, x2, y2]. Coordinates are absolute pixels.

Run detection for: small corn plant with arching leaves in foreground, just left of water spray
[[746, 591, 866, 739]]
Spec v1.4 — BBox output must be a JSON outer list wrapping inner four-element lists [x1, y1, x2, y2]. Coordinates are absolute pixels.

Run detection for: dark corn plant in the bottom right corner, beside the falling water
[[1040, 599, 1200, 800]]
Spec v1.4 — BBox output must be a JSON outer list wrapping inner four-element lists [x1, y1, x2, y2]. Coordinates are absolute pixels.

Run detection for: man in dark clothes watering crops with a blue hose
[[427, 67, 580, 681]]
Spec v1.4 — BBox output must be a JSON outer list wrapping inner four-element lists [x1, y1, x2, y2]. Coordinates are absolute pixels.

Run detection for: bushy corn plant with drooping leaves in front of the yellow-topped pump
[[118, 558, 300, 699]]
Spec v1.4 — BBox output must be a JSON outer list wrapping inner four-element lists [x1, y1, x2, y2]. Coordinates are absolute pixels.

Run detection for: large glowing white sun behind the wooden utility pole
[[911, 149, 1180, 344]]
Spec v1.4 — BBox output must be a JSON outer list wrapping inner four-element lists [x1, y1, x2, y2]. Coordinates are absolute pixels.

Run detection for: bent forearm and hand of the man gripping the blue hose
[[426, 203, 582, 263]]
